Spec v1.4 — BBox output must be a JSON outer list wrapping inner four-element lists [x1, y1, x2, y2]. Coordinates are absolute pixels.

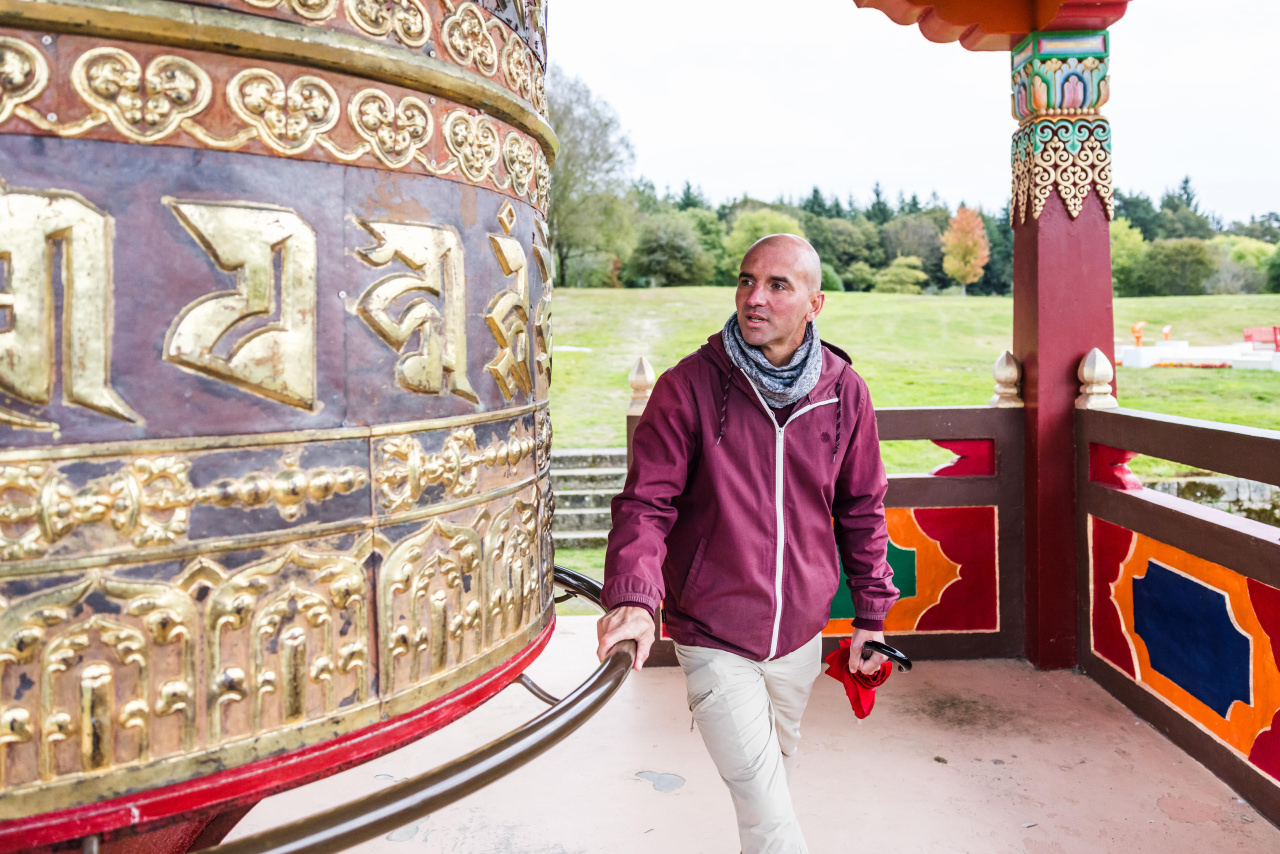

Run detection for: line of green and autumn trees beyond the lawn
[[548, 65, 1280, 296]]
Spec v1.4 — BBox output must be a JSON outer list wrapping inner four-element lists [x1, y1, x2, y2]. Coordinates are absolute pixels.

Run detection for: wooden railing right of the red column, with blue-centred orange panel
[[1076, 408, 1280, 821]]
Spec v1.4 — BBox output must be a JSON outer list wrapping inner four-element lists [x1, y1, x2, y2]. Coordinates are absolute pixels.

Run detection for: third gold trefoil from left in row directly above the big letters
[[227, 68, 340, 155]]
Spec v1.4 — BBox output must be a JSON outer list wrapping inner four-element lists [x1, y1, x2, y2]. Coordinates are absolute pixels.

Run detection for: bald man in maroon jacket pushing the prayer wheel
[[598, 234, 897, 854]]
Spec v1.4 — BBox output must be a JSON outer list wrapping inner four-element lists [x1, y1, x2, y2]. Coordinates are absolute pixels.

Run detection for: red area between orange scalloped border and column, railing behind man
[[913, 507, 1000, 631]]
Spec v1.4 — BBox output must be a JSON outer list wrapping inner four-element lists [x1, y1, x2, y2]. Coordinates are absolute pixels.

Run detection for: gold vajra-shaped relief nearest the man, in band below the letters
[[374, 425, 538, 512]]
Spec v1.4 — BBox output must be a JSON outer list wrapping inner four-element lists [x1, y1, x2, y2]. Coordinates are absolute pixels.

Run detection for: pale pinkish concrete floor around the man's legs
[[228, 617, 1280, 854]]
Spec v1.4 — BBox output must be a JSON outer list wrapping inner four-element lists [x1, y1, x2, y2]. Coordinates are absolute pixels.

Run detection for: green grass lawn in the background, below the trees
[[552, 288, 1280, 473]]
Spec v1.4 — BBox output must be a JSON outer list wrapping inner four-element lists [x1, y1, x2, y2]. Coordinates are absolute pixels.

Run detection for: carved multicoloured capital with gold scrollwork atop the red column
[[1010, 32, 1115, 224]]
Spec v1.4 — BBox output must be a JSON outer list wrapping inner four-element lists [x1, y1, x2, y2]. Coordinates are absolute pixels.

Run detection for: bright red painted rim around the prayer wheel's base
[[0, 615, 556, 854]]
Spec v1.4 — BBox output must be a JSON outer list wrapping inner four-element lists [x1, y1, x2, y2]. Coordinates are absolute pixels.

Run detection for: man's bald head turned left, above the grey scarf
[[737, 239, 823, 366]]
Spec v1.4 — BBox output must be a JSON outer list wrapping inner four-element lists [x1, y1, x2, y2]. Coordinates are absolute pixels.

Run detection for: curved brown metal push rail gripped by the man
[[186, 566, 636, 854]]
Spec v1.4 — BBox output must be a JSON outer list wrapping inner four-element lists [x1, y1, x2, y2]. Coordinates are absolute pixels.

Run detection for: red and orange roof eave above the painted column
[[854, 0, 1129, 50]]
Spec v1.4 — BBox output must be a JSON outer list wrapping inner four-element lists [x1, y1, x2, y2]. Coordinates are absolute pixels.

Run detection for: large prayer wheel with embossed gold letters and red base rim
[[0, 0, 556, 851]]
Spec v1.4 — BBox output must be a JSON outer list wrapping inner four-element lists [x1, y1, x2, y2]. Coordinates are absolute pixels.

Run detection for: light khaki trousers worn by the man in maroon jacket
[[676, 635, 822, 854]]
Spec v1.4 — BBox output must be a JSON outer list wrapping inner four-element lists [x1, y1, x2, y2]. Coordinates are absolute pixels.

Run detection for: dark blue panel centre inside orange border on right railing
[[1133, 561, 1253, 718]]
